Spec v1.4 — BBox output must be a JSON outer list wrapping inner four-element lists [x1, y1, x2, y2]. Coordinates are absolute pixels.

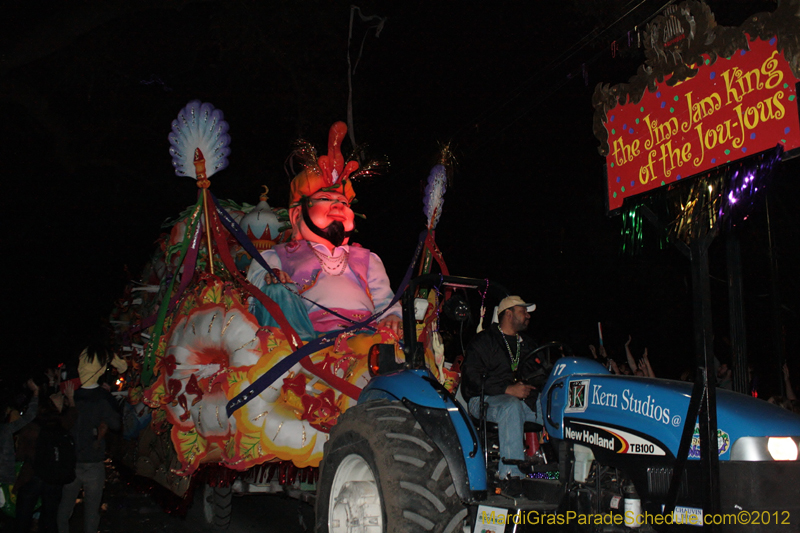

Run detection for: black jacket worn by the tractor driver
[[461, 324, 536, 401]]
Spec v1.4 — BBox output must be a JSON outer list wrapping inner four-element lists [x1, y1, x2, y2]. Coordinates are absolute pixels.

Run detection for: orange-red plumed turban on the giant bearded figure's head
[[289, 122, 358, 207]]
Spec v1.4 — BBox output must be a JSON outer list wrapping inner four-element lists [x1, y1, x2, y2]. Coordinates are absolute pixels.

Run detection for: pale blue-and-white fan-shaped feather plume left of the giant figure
[[169, 100, 231, 179]]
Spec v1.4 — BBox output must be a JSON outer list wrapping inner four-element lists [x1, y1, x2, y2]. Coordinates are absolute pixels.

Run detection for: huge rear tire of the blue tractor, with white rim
[[316, 400, 467, 533]]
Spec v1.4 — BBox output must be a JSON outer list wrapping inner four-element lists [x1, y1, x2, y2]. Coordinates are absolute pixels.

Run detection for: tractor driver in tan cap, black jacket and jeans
[[461, 296, 544, 479]]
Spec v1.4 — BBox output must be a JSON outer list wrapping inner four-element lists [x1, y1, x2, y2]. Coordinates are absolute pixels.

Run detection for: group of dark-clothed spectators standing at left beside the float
[[0, 344, 126, 533]]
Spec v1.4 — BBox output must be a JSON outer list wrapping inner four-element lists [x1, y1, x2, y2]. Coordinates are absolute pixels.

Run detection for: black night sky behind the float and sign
[[0, 0, 800, 394]]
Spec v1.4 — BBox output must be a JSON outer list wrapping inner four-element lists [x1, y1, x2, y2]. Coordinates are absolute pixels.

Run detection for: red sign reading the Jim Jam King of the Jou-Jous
[[605, 38, 800, 211]]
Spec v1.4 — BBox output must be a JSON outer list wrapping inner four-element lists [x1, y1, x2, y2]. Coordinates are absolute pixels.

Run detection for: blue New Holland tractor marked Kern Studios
[[316, 275, 800, 533]]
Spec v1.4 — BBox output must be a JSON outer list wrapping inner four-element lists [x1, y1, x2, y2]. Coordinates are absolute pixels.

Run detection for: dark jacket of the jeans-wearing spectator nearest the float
[[72, 387, 121, 463]]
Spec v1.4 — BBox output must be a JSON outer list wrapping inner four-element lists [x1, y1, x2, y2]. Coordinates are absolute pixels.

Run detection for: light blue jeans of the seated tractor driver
[[469, 394, 542, 479]]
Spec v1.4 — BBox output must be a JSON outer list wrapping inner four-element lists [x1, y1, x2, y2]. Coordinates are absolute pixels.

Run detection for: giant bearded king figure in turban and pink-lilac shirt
[[247, 122, 402, 340]]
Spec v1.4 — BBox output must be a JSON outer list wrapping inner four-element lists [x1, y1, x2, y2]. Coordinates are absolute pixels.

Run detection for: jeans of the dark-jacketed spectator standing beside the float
[[58, 463, 106, 533]]
